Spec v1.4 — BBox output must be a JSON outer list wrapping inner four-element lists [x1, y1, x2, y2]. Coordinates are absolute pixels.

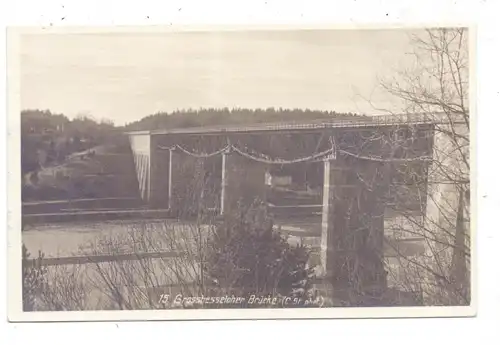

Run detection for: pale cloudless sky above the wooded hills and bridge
[[20, 29, 420, 125]]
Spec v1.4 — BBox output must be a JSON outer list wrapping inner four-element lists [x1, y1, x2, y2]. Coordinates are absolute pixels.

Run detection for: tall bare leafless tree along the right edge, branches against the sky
[[374, 28, 471, 305]]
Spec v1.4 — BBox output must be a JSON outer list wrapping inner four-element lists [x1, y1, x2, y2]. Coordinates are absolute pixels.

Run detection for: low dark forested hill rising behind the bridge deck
[[125, 108, 366, 131]]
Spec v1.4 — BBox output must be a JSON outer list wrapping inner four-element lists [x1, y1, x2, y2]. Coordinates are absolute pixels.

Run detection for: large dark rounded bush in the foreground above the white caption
[[203, 200, 314, 301]]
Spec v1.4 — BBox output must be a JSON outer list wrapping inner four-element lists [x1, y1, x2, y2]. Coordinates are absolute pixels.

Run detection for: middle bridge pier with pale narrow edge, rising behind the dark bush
[[220, 153, 267, 214]]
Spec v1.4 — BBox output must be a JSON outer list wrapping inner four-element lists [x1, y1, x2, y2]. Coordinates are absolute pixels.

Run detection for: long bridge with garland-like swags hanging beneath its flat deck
[[128, 114, 468, 293]]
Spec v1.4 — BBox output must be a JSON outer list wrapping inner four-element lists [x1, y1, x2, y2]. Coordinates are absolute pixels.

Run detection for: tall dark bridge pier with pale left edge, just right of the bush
[[320, 158, 387, 303]]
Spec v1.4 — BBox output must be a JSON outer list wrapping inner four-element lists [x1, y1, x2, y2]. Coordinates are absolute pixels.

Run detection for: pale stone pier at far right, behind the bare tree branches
[[424, 124, 471, 303]]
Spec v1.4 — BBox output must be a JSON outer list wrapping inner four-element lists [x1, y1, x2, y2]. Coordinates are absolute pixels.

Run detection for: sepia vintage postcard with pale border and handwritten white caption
[[8, 26, 476, 321]]
